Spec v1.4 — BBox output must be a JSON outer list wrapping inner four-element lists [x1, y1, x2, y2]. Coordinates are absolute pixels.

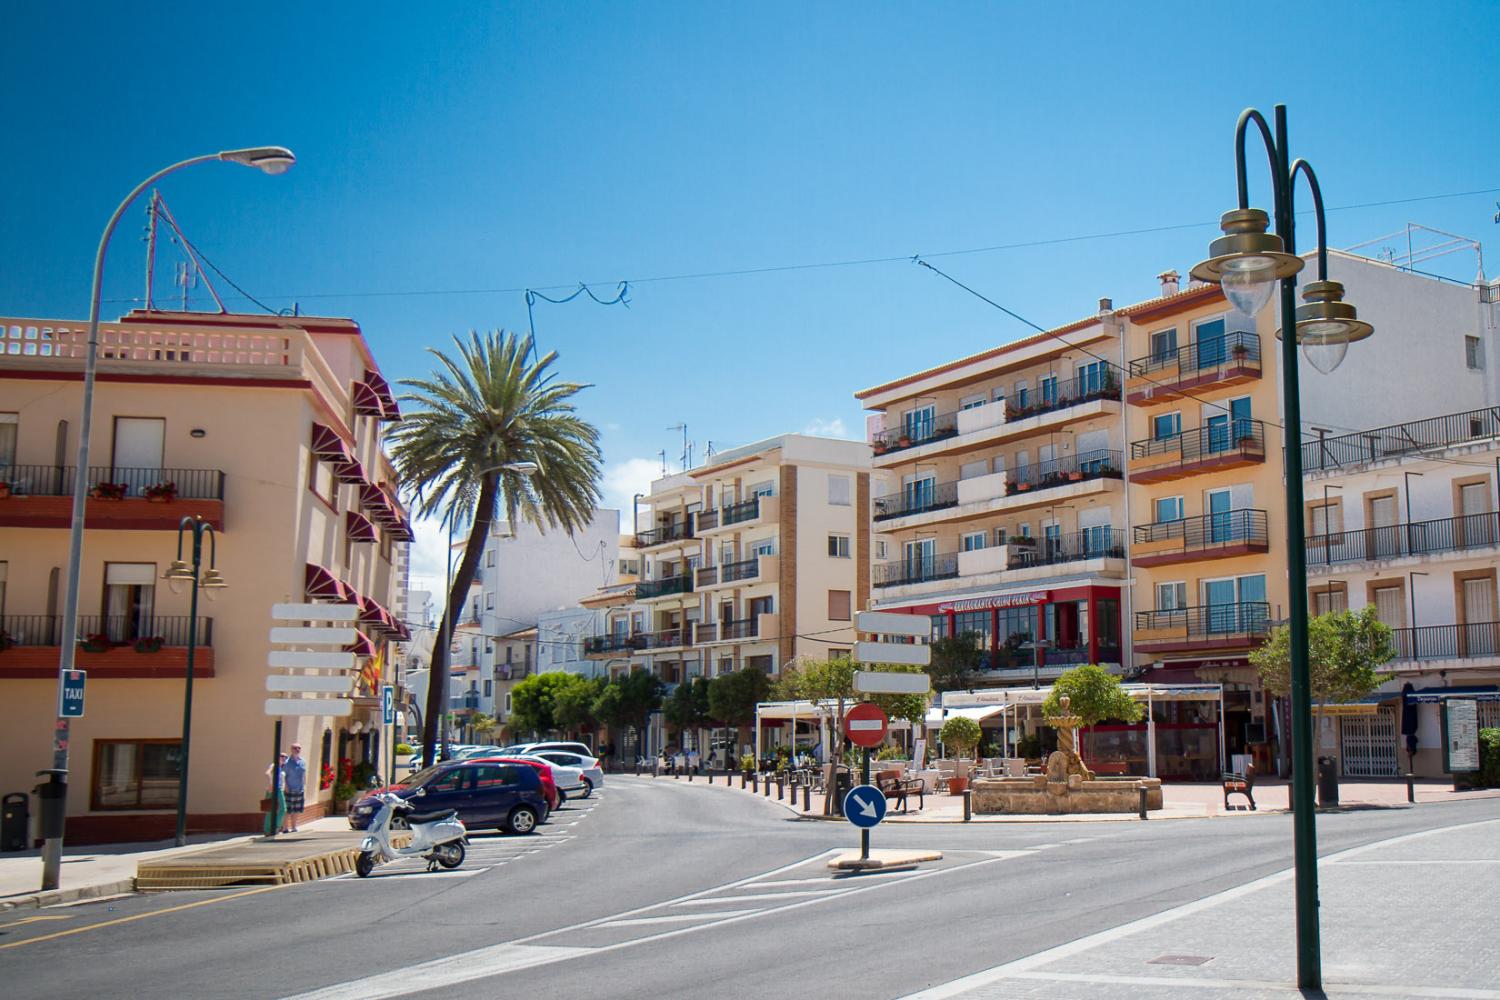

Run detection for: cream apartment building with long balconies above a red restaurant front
[[855, 308, 1127, 685]]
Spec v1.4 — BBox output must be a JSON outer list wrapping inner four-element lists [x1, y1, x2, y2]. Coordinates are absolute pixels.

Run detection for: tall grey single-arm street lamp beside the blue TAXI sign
[[42, 145, 297, 891]]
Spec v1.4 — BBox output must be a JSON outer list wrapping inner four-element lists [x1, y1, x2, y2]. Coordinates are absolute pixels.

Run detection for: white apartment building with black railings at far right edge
[[1302, 406, 1500, 777]]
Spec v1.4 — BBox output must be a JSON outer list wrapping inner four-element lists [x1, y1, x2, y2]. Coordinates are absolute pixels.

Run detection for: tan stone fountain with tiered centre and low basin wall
[[972, 696, 1161, 814]]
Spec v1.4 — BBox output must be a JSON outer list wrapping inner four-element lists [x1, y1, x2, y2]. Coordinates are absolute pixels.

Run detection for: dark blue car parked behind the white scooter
[[350, 760, 548, 834]]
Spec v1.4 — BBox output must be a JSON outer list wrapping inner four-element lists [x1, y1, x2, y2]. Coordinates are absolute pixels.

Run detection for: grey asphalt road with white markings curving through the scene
[[0, 777, 1500, 1000]]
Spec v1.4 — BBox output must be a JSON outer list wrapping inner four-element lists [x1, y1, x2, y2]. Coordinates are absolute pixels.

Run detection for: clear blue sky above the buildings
[[0, 3, 1500, 578]]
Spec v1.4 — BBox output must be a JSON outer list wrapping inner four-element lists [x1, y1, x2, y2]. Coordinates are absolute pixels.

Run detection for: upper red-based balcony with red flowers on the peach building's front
[[0, 465, 224, 531]]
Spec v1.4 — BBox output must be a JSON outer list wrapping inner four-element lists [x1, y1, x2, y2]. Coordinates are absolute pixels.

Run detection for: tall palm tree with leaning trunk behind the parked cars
[[390, 331, 600, 766]]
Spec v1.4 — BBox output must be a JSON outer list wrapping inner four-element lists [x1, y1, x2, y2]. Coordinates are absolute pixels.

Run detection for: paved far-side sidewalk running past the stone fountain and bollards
[[626, 772, 1500, 823]]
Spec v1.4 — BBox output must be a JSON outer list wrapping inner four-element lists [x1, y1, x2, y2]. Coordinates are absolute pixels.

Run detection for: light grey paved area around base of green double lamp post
[[908, 819, 1500, 1000]]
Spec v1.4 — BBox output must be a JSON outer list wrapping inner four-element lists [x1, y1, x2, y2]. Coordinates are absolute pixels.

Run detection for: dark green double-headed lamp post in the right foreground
[[1193, 105, 1374, 990]]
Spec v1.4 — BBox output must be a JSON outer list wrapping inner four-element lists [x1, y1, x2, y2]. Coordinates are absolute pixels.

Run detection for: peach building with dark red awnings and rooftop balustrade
[[0, 312, 411, 843]]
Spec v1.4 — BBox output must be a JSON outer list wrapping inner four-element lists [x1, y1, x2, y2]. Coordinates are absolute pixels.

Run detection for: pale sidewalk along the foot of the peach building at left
[[0, 816, 350, 910]]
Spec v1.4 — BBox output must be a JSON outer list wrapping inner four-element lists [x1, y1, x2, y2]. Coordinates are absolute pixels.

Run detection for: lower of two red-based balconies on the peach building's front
[[0, 615, 213, 679]]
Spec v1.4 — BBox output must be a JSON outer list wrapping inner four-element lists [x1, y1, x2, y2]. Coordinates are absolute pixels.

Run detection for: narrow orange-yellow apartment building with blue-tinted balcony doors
[[1119, 271, 1287, 769]]
